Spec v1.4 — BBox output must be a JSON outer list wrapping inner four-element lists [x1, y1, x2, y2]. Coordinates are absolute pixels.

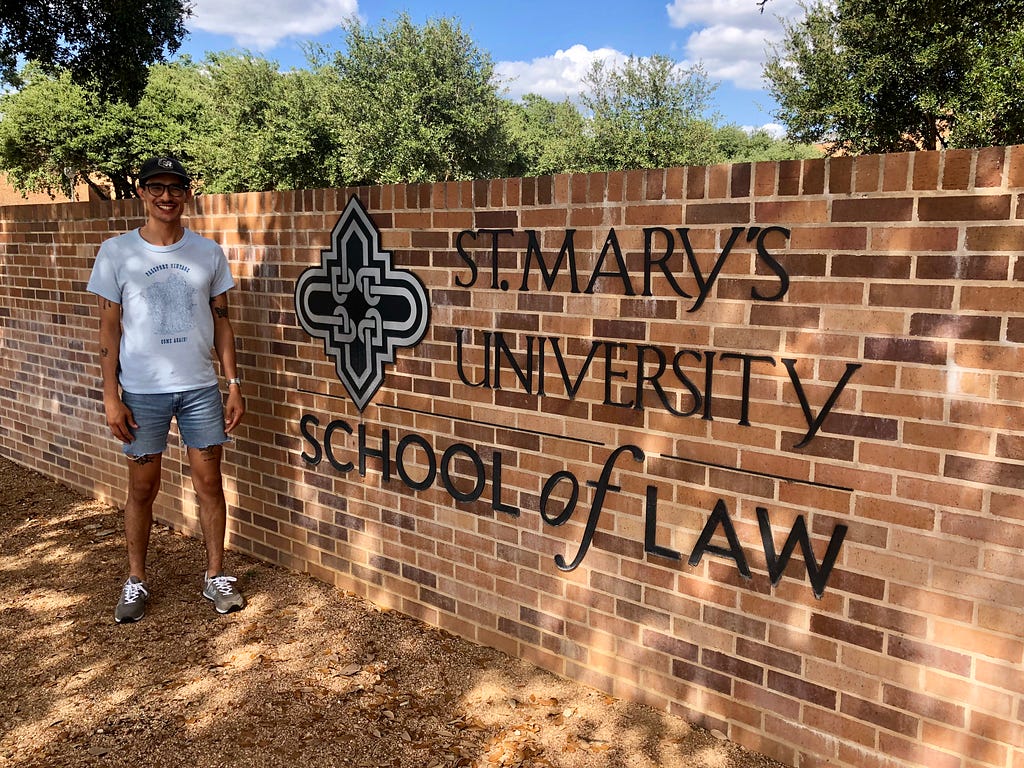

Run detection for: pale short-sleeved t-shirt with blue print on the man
[[86, 229, 234, 394]]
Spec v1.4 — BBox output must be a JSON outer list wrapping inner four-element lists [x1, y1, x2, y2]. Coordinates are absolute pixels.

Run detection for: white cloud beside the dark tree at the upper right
[[666, 0, 803, 90]]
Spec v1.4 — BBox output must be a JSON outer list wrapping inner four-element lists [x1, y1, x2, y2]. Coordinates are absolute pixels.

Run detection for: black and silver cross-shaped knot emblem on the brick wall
[[295, 197, 430, 411]]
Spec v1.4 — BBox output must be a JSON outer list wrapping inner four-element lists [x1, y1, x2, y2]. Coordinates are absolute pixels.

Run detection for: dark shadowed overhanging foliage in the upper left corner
[[0, 0, 191, 103]]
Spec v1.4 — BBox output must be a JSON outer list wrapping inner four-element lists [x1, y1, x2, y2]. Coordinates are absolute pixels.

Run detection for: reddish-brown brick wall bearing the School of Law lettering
[[0, 147, 1024, 768]]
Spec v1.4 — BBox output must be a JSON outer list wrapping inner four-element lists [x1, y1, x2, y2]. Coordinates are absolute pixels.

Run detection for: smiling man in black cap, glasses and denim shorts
[[87, 157, 246, 624]]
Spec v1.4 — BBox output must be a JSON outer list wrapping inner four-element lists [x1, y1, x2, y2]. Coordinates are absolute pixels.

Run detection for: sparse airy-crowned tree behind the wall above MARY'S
[[581, 55, 715, 170]]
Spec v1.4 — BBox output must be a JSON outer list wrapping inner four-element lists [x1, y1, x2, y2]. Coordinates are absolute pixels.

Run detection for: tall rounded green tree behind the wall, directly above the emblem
[[335, 14, 509, 183]]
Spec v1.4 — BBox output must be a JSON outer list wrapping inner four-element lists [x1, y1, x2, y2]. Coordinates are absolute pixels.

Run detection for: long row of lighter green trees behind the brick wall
[[0, 13, 819, 198]]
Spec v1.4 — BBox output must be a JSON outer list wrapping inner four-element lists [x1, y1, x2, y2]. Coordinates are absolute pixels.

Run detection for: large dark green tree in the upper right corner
[[765, 0, 1024, 153]]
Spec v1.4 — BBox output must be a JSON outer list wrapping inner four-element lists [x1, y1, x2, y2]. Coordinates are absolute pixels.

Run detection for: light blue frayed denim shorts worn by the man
[[121, 384, 228, 457]]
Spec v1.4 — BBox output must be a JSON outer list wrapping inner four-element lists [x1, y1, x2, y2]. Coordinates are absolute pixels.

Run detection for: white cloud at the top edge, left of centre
[[188, 0, 358, 50]]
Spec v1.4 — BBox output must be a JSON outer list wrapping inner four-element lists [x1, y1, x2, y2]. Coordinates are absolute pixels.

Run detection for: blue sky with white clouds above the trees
[[181, 0, 799, 129]]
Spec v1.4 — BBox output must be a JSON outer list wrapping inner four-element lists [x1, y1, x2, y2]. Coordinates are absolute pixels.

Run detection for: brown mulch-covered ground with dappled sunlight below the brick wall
[[0, 459, 783, 768]]
